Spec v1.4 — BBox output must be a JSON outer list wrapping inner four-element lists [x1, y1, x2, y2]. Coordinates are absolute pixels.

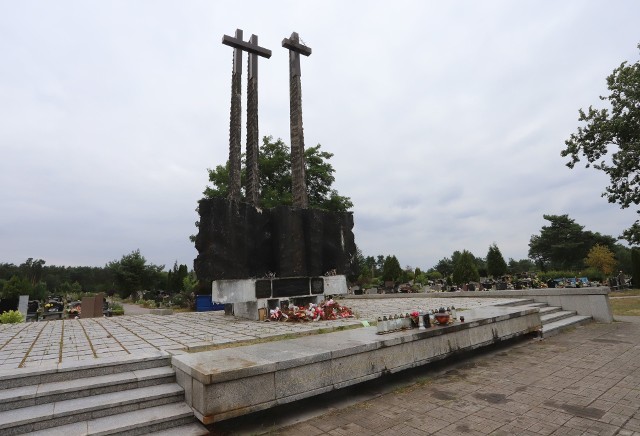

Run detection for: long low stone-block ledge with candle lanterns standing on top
[[172, 307, 541, 424]]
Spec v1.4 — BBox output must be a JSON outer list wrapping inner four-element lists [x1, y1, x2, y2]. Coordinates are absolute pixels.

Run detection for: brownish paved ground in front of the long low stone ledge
[[210, 317, 640, 436]]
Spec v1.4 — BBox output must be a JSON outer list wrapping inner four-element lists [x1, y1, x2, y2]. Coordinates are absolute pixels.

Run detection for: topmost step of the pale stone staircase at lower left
[[0, 352, 171, 390]]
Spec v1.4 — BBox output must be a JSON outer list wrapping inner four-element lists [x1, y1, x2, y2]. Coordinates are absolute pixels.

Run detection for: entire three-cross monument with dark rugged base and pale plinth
[[194, 29, 356, 319]]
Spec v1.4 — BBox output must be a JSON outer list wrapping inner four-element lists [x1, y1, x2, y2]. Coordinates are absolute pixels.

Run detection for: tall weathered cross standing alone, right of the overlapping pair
[[282, 32, 311, 209]]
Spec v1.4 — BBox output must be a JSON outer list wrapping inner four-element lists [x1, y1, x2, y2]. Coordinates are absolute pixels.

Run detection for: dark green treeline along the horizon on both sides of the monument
[[0, 215, 640, 300]]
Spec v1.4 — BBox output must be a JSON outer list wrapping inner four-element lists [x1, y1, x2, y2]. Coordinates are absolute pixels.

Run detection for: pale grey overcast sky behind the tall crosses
[[0, 0, 640, 269]]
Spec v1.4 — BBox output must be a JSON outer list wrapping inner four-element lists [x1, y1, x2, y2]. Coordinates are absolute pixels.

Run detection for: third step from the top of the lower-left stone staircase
[[0, 382, 184, 435]]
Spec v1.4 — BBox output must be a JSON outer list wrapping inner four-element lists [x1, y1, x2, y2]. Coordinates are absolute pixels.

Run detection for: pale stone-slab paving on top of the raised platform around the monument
[[0, 298, 520, 371]]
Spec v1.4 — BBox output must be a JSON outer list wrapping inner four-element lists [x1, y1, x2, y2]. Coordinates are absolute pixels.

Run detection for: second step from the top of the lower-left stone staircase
[[0, 366, 175, 412]]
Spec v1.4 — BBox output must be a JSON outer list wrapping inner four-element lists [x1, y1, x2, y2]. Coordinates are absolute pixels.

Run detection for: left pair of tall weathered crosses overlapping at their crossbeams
[[222, 29, 271, 206]]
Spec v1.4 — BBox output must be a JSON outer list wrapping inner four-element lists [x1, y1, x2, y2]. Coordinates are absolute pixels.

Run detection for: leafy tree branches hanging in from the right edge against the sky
[[561, 44, 640, 245]]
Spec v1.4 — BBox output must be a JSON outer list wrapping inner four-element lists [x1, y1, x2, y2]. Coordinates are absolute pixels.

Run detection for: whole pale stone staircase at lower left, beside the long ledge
[[0, 355, 209, 436]]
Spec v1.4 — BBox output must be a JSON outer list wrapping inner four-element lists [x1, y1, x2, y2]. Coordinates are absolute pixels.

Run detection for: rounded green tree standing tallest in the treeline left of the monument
[[106, 250, 164, 298]]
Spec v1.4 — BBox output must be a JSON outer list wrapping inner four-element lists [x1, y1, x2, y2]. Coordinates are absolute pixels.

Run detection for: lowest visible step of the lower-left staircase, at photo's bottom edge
[[25, 402, 202, 436]]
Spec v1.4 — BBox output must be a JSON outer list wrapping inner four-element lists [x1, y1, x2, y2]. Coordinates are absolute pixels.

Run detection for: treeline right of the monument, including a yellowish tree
[[356, 214, 640, 288]]
